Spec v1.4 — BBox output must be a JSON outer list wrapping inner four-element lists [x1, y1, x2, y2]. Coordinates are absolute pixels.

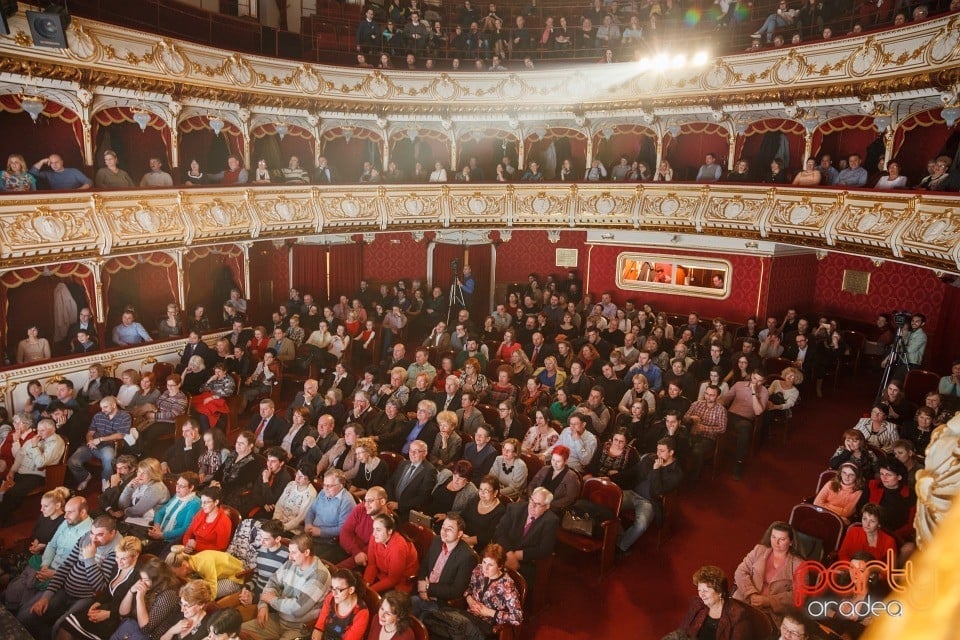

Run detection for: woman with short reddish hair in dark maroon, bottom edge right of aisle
[[671, 565, 769, 640]]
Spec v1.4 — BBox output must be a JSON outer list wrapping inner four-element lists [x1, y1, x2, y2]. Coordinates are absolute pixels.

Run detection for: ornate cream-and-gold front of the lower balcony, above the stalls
[[0, 183, 960, 272]]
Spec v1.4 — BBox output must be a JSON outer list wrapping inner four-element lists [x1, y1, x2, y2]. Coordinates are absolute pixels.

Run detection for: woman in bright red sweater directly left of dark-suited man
[[363, 513, 419, 594]]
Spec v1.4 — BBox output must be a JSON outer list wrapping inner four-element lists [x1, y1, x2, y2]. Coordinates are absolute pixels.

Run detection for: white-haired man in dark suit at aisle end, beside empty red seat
[[493, 487, 560, 597]]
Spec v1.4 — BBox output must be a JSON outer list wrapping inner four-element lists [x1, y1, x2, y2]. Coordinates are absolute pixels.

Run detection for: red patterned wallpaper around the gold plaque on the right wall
[[813, 253, 945, 334]]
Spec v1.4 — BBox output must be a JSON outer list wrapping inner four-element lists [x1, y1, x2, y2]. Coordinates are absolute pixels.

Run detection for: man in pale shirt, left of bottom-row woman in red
[[242, 533, 330, 640]]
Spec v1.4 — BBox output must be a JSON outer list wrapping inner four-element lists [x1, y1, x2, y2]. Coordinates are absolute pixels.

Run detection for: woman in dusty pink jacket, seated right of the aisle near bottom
[[733, 521, 803, 624]]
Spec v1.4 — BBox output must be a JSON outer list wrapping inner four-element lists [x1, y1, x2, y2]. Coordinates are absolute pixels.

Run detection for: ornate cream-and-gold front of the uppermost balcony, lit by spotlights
[[0, 14, 960, 114]]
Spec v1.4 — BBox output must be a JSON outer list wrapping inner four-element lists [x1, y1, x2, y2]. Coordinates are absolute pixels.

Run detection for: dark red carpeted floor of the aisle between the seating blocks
[[0, 374, 878, 640]]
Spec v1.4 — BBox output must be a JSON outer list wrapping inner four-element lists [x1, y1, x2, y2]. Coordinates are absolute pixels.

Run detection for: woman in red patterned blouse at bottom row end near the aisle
[[424, 544, 523, 638]]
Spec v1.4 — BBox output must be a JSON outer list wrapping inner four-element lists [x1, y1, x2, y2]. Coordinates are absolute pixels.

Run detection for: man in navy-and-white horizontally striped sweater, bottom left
[[17, 515, 120, 638]]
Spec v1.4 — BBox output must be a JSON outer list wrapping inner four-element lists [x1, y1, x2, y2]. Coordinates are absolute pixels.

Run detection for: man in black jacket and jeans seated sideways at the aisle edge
[[617, 437, 683, 553]]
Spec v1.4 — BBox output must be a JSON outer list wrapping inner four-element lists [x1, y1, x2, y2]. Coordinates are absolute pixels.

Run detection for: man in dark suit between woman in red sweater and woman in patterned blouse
[[413, 513, 476, 616]]
